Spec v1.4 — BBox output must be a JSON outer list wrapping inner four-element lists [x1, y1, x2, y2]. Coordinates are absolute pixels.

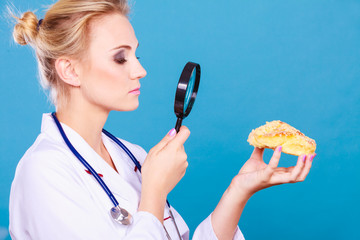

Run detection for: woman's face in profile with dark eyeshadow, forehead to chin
[[78, 14, 146, 111]]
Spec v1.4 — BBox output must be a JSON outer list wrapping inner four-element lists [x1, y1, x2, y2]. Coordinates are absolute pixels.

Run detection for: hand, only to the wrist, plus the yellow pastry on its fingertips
[[231, 121, 316, 199]]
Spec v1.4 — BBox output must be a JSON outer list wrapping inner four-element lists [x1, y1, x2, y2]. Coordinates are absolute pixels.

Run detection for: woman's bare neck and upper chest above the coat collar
[[56, 100, 109, 155]]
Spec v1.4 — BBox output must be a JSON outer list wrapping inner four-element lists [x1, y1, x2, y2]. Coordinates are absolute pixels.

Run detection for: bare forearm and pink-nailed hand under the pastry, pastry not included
[[211, 146, 315, 239]]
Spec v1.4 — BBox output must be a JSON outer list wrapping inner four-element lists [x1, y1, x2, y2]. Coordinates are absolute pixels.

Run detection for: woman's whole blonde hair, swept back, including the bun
[[13, 0, 129, 106]]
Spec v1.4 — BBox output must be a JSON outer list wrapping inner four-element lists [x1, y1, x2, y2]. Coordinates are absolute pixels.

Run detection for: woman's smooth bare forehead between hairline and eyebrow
[[89, 13, 137, 49]]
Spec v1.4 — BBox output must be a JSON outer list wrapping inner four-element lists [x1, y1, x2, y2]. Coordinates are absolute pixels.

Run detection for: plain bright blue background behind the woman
[[0, 0, 360, 240]]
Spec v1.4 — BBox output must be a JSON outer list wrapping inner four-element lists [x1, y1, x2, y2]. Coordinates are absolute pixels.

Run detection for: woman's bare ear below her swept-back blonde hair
[[55, 57, 81, 87]]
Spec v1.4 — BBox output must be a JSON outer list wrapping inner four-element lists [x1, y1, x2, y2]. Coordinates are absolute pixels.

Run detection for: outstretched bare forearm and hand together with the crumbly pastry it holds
[[211, 121, 316, 239]]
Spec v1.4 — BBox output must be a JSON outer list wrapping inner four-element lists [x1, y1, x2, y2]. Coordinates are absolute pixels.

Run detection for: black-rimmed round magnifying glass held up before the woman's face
[[174, 62, 200, 132]]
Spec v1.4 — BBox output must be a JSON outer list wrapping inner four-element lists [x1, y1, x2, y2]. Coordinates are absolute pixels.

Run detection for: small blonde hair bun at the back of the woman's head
[[13, 12, 38, 45]]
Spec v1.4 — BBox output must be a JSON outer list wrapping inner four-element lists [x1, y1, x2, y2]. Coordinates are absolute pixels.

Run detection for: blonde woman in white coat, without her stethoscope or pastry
[[10, 0, 314, 239]]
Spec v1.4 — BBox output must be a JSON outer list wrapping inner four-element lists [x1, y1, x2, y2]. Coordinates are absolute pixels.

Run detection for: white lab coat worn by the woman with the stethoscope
[[9, 114, 244, 240]]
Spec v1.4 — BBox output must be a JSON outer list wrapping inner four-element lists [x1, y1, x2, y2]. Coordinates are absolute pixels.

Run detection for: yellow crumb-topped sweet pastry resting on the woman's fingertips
[[247, 120, 316, 156]]
